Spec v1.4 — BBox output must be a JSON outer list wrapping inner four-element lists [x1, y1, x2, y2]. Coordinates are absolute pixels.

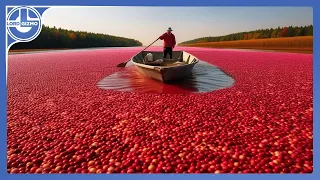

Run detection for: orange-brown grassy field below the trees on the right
[[180, 36, 313, 53]]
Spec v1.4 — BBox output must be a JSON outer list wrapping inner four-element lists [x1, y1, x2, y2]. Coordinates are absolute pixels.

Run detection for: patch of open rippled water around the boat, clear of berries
[[98, 61, 234, 94]]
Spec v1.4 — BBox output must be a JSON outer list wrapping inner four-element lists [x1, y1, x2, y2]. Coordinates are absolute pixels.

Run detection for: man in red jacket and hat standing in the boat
[[159, 27, 176, 59]]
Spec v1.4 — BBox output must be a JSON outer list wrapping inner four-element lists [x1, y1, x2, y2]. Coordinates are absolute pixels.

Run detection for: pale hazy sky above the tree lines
[[42, 6, 313, 45]]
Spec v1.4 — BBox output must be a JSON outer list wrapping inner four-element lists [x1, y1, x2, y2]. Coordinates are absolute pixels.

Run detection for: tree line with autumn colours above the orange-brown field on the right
[[180, 25, 313, 44]]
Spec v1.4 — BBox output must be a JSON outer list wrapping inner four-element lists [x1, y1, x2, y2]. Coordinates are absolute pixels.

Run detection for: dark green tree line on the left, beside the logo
[[11, 25, 142, 49]]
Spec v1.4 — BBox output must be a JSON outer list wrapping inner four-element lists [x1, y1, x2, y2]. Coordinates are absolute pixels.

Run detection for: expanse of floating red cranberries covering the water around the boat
[[7, 47, 313, 173]]
